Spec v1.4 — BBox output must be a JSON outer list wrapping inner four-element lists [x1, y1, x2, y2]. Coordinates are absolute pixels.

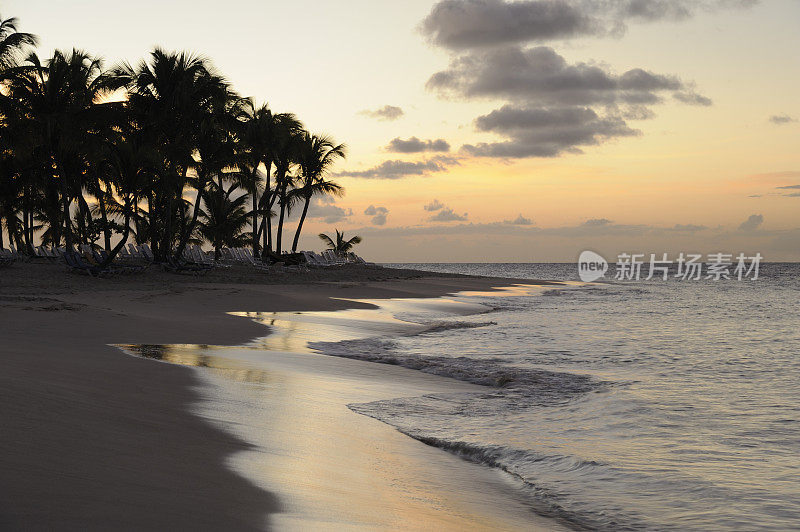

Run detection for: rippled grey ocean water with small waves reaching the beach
[[322, 264, 800, 531]]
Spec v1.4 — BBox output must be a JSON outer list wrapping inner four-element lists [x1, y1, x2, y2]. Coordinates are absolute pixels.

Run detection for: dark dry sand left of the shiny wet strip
[[0, 264, 564, 529]]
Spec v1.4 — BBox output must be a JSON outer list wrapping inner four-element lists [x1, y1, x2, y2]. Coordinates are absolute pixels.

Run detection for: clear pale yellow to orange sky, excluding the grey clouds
[[7, 0, 800, 262]]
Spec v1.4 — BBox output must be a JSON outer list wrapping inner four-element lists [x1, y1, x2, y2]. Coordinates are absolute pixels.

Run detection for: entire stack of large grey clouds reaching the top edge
[[420, 0, 740, 158]]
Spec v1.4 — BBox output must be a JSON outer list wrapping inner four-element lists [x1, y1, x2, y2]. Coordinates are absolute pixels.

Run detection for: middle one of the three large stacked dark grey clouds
[[427, 46, 700, 106]]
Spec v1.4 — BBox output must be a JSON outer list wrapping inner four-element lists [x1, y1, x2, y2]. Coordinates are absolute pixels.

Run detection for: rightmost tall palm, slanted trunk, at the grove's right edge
[[292, 132, 346, 252]]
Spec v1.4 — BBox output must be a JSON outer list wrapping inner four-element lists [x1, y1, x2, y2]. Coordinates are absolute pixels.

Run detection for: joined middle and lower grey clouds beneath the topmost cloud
[[428, 46, 711, 158]]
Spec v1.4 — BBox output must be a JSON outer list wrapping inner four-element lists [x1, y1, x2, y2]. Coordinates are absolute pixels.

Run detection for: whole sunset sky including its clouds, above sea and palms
[[7, 0, 800, 262]]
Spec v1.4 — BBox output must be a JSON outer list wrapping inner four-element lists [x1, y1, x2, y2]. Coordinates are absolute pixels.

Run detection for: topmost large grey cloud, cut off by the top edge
[[420, 0, 757, 50]]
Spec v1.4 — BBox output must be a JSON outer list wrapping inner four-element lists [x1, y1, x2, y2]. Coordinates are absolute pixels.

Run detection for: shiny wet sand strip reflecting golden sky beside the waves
[[114, 284, 561, 530]]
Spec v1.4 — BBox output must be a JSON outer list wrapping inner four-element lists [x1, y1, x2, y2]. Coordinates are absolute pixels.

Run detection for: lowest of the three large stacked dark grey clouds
[[462, 105, 639, 157]]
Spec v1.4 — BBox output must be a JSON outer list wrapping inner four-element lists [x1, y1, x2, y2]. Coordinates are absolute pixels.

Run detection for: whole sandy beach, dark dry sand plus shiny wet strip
[[0, 263, 555, 530]]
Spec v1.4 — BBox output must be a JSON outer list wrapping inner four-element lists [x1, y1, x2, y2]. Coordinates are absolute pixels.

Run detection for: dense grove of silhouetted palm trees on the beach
[[0, 17, 346, 262]]
